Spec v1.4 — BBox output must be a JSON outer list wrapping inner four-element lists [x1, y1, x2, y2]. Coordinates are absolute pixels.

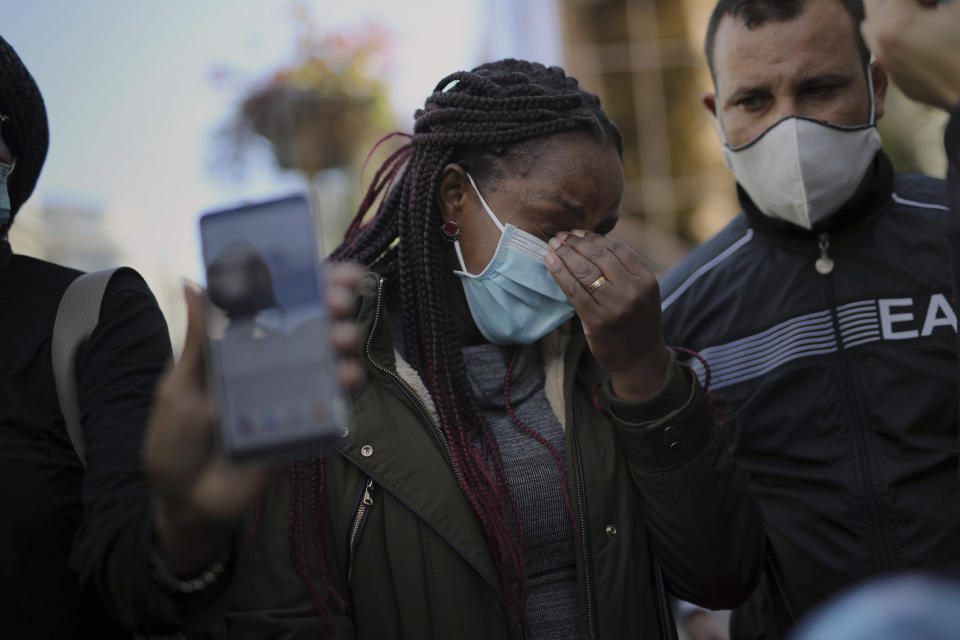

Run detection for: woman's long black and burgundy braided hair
[[316, 59, 623, 626]]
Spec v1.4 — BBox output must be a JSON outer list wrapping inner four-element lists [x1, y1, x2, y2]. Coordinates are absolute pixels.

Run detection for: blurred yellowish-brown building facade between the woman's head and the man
[[561, 0, 738, 271]]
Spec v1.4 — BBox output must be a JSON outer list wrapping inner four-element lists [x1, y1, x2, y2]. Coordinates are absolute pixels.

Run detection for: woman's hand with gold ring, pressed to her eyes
[[545, 229, 669, 400]]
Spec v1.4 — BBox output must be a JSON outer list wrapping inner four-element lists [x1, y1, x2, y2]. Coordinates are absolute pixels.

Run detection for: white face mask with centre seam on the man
[[717, 71, 880, 229]]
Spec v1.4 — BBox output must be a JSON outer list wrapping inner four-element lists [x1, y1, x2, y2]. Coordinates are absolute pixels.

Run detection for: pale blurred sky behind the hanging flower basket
[[0, 0, 496, 277]]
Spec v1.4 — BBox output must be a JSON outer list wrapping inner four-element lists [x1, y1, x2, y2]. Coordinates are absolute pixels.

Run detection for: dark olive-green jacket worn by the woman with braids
[[227, 275, 764, 640]]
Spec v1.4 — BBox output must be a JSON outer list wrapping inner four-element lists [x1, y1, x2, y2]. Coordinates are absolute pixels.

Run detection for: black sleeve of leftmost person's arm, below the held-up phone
[[71, 269, 228, 633]]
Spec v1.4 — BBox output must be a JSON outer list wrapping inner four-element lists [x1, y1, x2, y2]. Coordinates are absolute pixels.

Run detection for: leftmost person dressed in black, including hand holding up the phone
[[0, 38, 368, 640]]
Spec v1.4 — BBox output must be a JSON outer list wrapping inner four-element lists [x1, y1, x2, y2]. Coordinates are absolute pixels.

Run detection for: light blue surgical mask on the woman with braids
[[454, 174, 574, 344]]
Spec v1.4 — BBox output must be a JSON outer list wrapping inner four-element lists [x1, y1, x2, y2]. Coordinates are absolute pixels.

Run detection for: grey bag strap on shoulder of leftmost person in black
[[51, 269, 117, 467]]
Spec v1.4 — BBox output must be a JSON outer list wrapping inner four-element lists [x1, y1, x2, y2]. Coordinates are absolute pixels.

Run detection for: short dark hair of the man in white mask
[[704, 0, 870, 84]]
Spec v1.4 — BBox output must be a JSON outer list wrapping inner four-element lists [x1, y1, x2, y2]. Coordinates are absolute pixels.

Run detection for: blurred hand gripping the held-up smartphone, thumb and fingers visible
[[143, 265, 364, 575]]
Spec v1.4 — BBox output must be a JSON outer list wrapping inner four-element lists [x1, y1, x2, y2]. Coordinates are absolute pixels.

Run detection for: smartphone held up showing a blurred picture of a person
[[200, 195, 348, 461]]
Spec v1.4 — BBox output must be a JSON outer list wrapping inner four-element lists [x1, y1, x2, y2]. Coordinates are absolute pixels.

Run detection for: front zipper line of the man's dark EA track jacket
[[818, 244, 893, 571]]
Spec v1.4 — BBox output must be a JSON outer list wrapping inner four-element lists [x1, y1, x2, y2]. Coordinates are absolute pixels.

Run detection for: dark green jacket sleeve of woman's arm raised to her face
[[601, 356, 765, 609]]
